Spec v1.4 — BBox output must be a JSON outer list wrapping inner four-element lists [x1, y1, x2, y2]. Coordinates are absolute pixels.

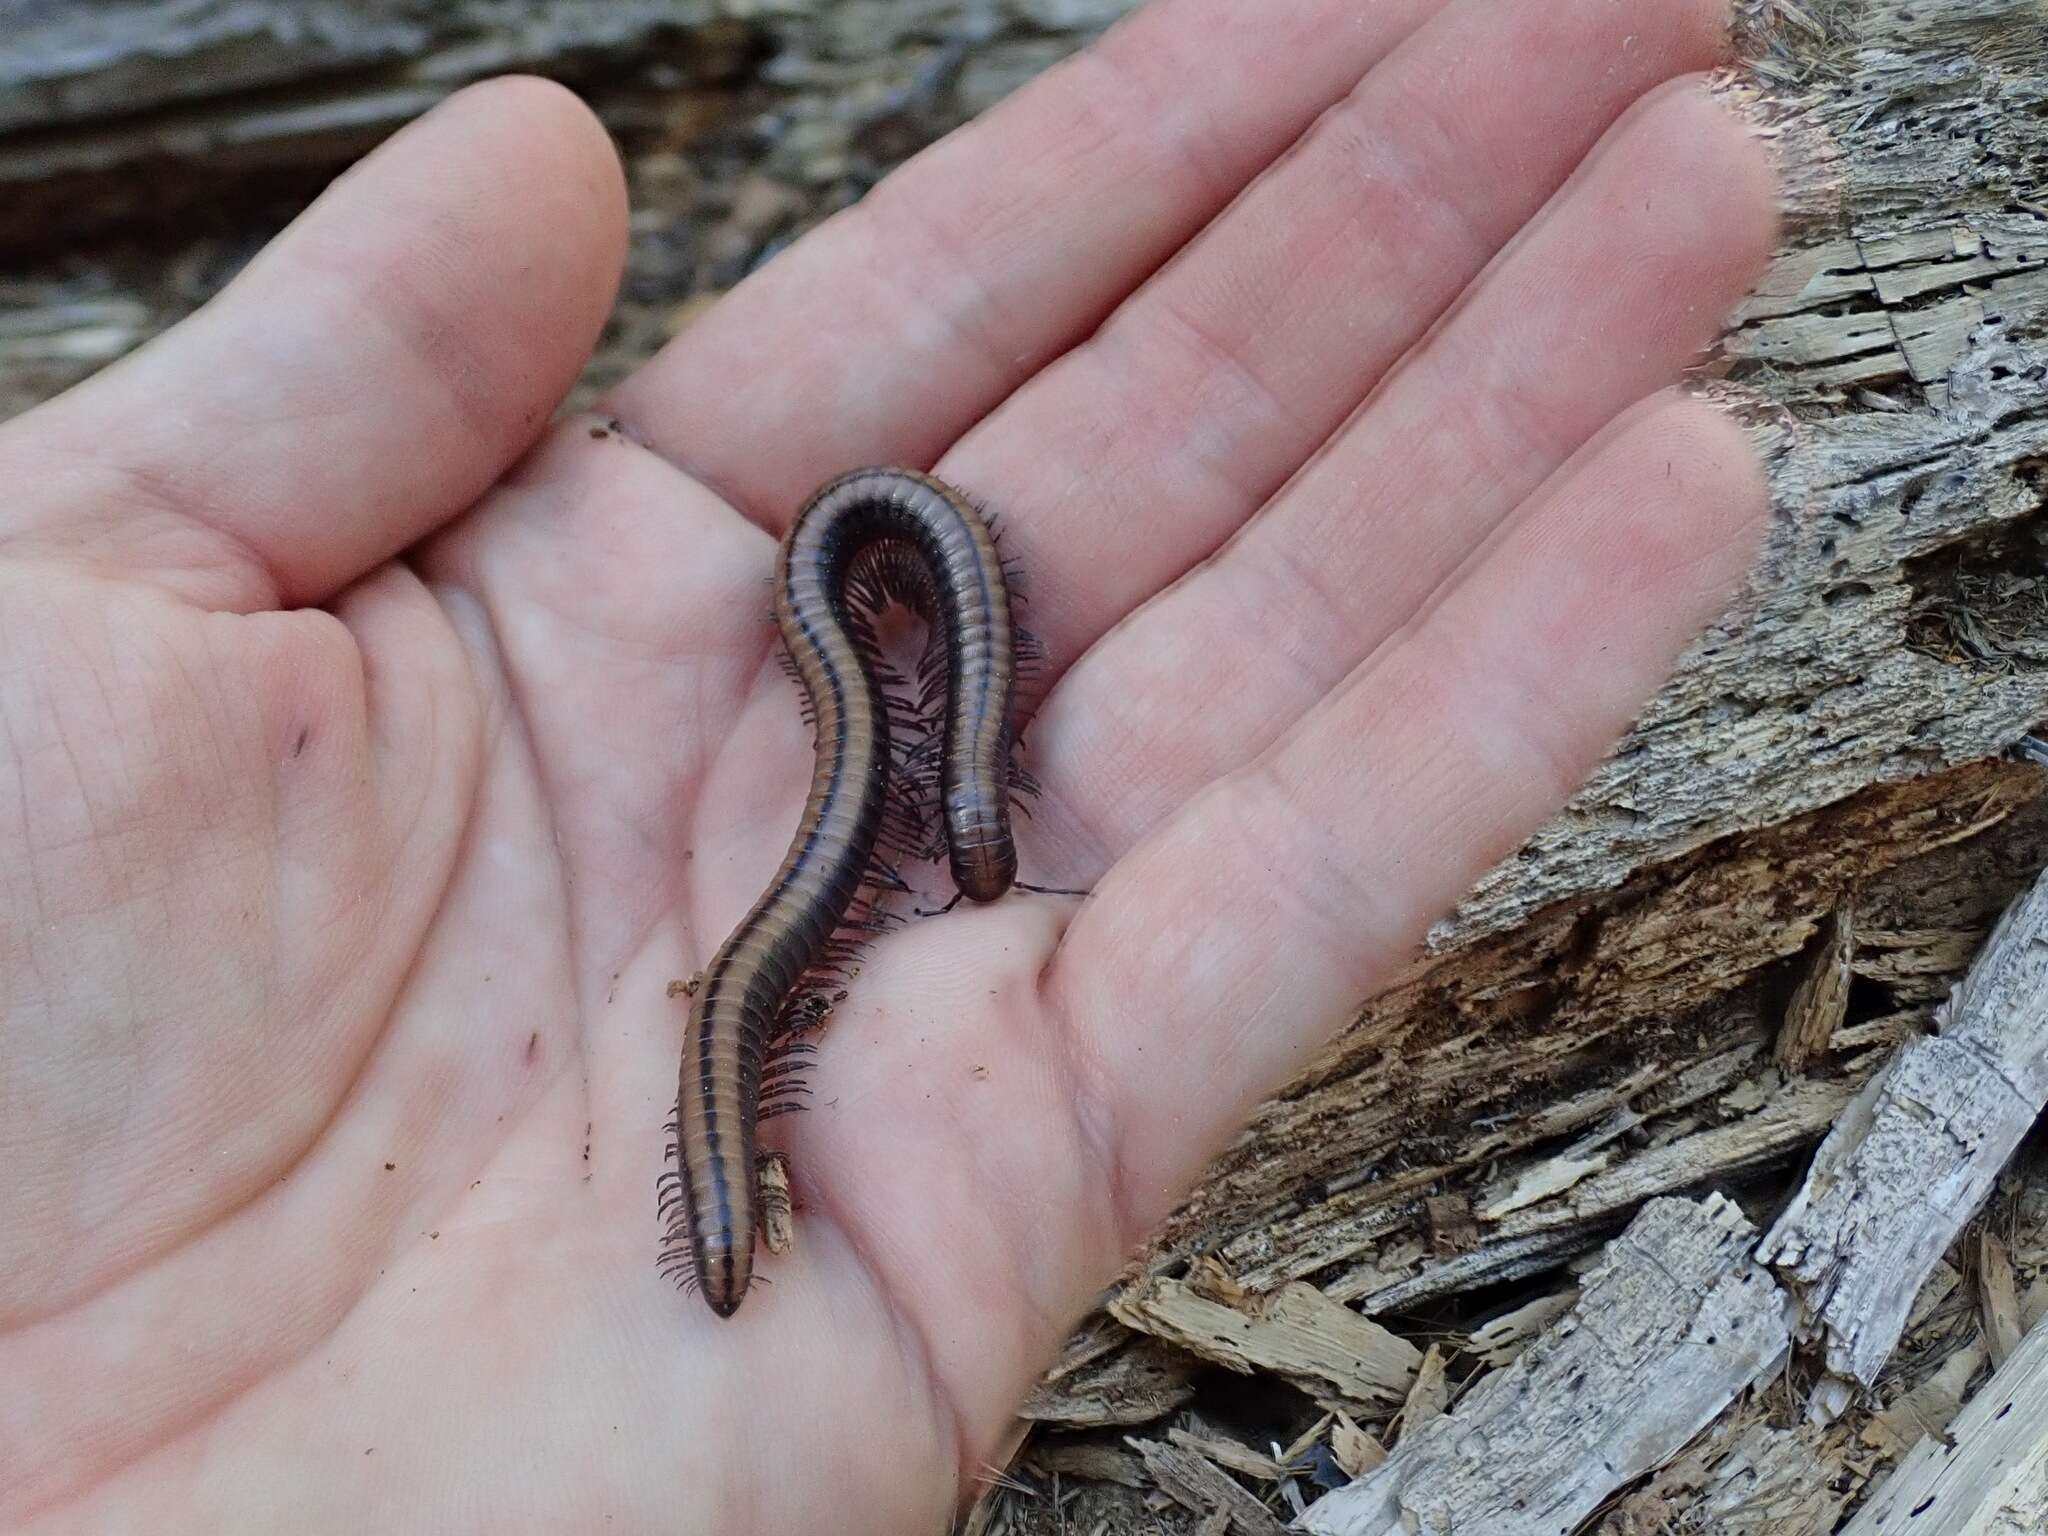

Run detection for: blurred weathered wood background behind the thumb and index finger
[[0, 0, 1130, 416]]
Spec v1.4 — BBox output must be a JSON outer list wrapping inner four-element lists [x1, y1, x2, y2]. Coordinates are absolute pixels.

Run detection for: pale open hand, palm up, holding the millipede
[[0, 0, 1774, 1536]]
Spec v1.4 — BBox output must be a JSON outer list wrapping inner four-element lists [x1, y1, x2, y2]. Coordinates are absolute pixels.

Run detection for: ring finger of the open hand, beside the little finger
[[1034, 82, 1776, 868]]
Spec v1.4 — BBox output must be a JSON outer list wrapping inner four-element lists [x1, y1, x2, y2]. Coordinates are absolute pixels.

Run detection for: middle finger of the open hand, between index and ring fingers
[[938, 0, 1726, 692]]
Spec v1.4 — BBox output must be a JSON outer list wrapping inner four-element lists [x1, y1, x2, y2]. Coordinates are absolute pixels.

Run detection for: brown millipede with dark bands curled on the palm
[[662, 469, 1030, 1317]]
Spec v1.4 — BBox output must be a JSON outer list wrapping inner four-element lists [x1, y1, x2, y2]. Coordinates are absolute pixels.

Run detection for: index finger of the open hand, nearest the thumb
[[608, 0, 1444, 532]]
